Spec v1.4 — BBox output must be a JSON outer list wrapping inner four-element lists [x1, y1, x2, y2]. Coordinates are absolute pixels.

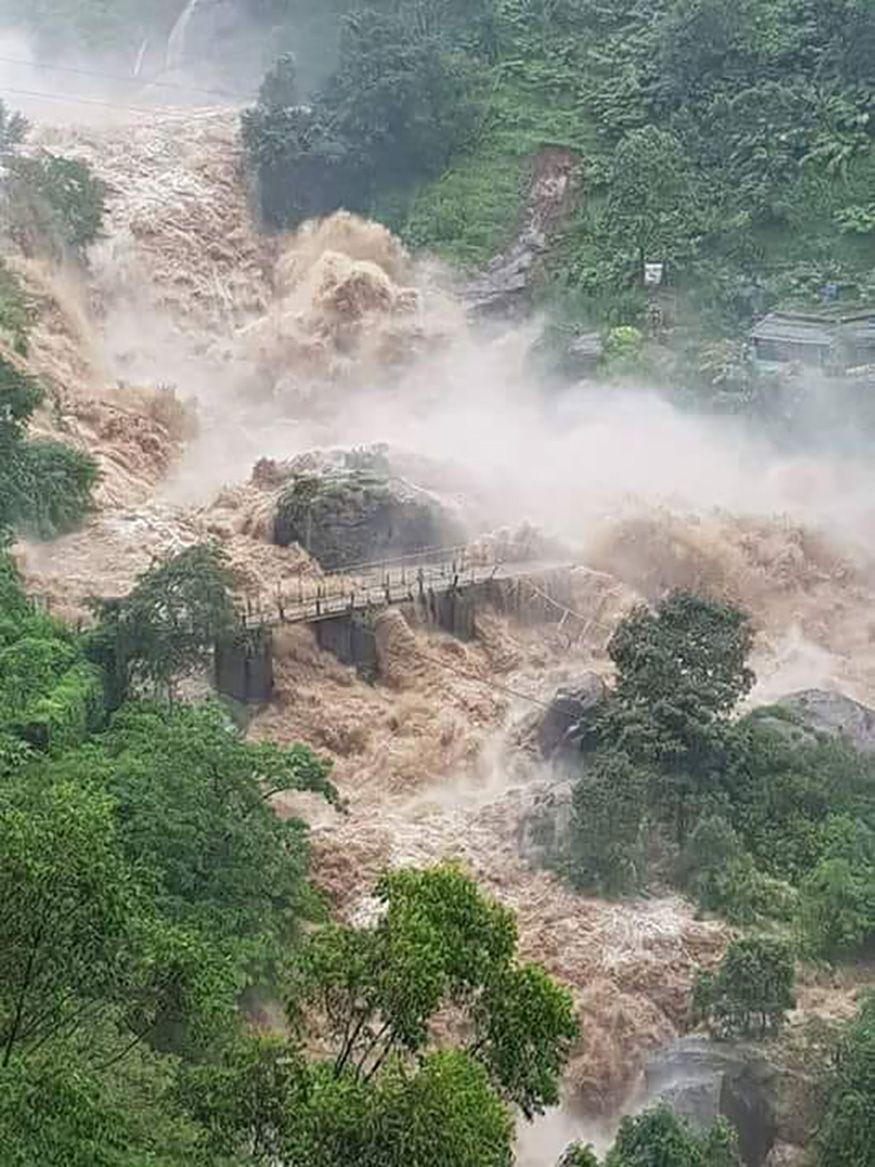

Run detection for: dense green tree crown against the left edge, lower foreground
[[0, 783, 144, 1065]]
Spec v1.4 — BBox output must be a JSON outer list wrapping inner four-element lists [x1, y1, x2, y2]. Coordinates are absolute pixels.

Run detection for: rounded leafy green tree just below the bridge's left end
[[56, 704, 336, 970]]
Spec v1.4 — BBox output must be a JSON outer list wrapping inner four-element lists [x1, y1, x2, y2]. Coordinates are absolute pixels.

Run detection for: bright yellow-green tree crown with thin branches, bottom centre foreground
[[289, 867, 576, 1116]]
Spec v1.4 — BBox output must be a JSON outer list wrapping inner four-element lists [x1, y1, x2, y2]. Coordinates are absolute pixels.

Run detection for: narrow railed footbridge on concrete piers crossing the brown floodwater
[[216, 546, 592, 701]]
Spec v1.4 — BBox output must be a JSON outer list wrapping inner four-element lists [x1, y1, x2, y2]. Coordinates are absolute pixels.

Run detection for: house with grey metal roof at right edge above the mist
[[750, 307, 875, 372]]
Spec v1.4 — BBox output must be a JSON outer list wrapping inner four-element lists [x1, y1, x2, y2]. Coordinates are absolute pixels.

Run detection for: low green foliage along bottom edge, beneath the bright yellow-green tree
[[184, 1040, 513, 1167]]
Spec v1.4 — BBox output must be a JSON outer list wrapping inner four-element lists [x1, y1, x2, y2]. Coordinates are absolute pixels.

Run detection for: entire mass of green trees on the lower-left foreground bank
[[0, 548, 578, 1167]]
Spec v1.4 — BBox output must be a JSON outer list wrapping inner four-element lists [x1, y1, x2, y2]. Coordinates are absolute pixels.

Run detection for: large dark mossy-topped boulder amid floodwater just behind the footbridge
[[274, 468, 464, 571]]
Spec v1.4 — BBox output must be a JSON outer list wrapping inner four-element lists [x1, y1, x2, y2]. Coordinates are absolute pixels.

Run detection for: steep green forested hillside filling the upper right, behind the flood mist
[[244, 0, 875, 380]]
